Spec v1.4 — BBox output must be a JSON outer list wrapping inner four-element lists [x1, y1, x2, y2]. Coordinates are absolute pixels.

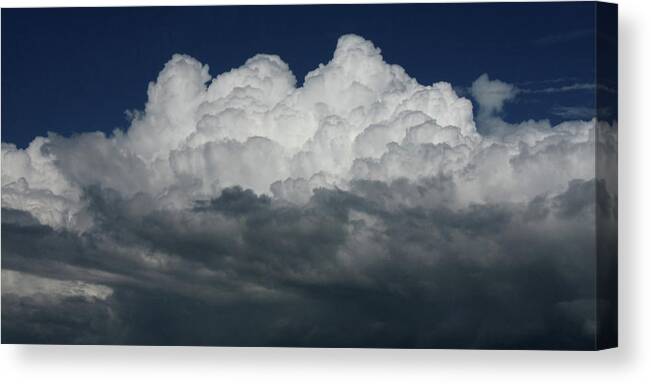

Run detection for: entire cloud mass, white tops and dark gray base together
[[2, 35, 616, 348]]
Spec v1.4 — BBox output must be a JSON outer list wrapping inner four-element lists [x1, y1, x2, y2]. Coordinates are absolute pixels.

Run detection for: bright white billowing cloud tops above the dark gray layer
[[2, 35, 594, 228]]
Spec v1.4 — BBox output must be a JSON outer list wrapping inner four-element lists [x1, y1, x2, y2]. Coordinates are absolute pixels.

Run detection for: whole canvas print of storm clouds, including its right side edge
[[1, 2, 618, 350]]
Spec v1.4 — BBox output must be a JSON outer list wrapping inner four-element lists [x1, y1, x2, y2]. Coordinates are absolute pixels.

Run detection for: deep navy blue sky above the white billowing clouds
[[2, 2, 595, 147]]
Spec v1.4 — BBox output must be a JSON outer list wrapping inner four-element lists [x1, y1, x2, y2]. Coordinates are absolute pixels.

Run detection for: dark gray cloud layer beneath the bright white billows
[[2, 176, 608, 349]]
